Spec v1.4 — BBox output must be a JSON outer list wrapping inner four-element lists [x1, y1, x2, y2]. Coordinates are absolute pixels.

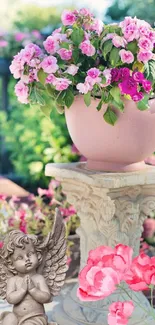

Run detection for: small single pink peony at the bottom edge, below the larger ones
[[108, 301, 134, 325]]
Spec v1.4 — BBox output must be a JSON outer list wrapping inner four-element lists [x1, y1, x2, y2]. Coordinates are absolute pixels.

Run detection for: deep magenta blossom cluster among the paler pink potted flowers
[[111, 68, 152, 102]]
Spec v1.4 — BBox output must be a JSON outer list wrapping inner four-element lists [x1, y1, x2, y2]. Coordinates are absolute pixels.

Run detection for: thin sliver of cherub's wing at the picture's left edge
[[0, 256, 9, 300]]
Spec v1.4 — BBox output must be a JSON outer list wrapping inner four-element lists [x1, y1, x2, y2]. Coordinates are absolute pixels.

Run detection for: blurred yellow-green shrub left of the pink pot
[[0, 81, 77, 188]]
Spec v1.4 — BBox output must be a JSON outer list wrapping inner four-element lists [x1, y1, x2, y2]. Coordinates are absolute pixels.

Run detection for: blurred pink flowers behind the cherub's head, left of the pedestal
[[0, 179, 79, 263]]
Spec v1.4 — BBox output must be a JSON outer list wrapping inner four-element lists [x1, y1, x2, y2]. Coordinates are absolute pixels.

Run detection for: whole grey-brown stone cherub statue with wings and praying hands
[[0, 210, 67, 325]]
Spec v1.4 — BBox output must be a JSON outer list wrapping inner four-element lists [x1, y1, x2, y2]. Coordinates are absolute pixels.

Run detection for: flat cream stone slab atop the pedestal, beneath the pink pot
[[45, 162, 155, 189]]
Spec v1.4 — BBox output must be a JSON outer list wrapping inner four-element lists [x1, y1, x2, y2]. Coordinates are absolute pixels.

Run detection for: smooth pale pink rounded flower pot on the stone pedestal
[[65, 95, 155, 171]]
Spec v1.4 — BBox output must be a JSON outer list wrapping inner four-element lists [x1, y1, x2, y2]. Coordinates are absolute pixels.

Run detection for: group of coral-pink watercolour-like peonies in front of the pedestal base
[[77, 244, 155, 325]]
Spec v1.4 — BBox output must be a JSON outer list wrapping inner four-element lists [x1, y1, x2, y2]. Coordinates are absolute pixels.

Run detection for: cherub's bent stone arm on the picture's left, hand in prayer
[[6, 277, 27, 305]]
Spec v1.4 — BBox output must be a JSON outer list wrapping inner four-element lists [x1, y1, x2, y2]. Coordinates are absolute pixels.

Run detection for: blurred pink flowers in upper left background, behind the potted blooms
[[0, 30, 43, 59]]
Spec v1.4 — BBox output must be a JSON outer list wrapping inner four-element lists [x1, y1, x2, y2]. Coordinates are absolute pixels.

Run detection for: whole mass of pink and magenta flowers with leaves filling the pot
[[10, 8, 155, 125]]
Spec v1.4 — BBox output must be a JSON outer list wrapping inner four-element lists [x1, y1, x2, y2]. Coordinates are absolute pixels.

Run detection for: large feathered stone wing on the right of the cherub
[[37, 209, 68, 296]]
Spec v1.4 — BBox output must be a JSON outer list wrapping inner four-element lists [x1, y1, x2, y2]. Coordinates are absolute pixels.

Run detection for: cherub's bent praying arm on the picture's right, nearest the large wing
[[28, 275, 51, 304]]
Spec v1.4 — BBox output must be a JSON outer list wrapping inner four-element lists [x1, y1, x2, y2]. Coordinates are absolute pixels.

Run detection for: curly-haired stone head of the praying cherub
[[1, 230, 42, 275]]
